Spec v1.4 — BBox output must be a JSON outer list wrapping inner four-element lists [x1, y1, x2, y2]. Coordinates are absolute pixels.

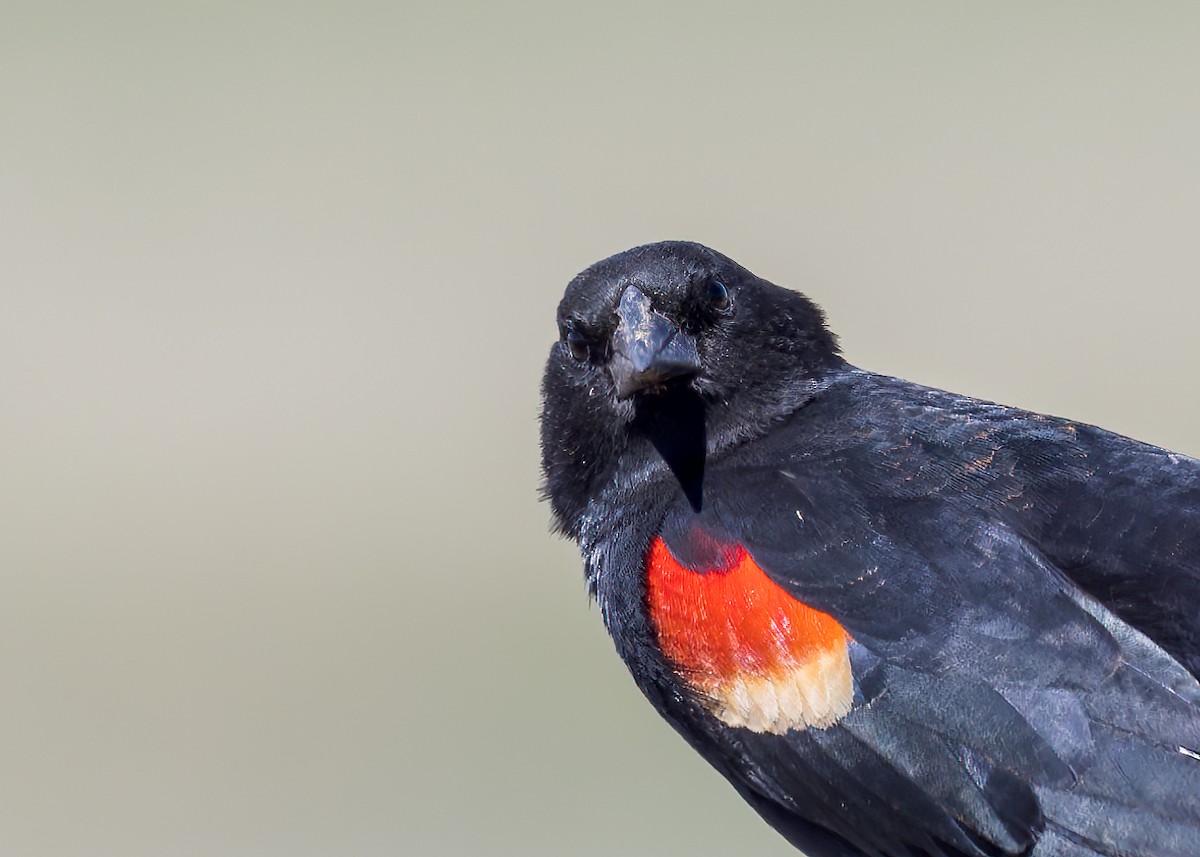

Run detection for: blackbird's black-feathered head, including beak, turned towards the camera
[[541, 241, 840, 532]]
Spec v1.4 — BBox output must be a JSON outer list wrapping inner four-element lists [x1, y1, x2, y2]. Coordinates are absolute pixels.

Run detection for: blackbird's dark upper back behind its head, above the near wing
[[820, 372, 1200, 675]]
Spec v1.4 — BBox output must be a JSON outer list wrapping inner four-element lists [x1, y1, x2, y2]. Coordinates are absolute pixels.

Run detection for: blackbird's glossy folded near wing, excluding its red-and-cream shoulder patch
[[664, 410, 1200, 857]]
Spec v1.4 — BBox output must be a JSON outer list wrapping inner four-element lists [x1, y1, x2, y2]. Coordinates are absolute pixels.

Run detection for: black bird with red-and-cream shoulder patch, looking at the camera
[[540, 241, 1200, 857]]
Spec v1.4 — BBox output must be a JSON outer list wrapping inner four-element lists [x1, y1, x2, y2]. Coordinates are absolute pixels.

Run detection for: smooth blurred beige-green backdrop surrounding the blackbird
[[0, 0, 1200, 857]]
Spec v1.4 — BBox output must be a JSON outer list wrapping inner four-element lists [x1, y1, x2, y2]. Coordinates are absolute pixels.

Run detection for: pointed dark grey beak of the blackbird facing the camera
[[608, 286, 700, 398]]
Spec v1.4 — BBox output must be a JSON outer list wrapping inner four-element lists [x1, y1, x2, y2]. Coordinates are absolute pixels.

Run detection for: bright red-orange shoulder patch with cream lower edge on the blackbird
[[646, 538, 854, 733]]
